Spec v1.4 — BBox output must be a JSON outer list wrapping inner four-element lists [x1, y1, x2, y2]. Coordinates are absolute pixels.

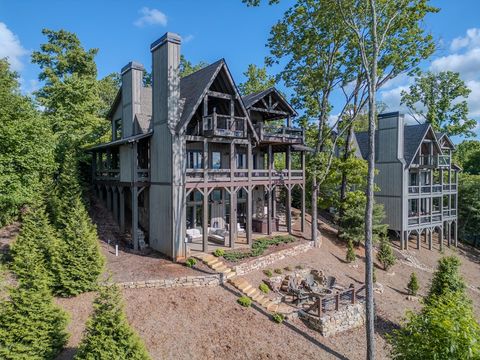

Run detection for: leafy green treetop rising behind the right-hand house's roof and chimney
[[401, 71, 477, 136]]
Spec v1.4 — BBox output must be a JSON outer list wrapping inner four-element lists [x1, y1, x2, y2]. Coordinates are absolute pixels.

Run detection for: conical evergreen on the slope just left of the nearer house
[[55, 195, 104, 296]]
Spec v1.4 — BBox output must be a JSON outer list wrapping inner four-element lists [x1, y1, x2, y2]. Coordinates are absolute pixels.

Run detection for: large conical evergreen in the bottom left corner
[[0, 246, 68, 360]]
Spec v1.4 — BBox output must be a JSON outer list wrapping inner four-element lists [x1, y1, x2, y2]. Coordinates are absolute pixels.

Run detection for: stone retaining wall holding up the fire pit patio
[[299, 302, 366, 337]]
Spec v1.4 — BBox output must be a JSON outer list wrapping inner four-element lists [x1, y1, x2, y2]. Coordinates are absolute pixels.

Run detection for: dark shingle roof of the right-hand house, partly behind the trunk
[[355, 124, 430, 165]]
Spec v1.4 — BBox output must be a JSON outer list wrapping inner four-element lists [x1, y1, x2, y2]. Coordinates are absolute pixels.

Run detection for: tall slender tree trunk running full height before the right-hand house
[[365, 0, 378, 360]]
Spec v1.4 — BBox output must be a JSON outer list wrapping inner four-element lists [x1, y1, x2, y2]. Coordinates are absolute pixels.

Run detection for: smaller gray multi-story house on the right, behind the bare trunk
[[355, 112, 460, 249]]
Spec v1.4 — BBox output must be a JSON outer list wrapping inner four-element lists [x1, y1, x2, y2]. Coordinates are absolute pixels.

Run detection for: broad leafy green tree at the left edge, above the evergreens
[[0, 59, 56, 227]]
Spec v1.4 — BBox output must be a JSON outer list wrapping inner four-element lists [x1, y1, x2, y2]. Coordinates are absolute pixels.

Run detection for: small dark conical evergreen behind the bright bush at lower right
[[425, 256, 466, 303]]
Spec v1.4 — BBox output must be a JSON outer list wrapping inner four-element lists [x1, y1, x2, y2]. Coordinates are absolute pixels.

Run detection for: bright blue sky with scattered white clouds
[[0, 0, 480, 140]]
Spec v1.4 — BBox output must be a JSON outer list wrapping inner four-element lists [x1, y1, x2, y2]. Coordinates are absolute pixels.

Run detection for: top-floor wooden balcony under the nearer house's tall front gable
[[203, 113, 247, 138]]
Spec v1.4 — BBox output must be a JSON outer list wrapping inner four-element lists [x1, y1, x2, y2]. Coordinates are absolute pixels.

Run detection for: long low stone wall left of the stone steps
[[117, 274, 223, 289]]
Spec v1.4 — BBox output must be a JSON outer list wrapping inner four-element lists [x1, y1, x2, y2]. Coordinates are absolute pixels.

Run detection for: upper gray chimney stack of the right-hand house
[[375, 111, 404, 163]]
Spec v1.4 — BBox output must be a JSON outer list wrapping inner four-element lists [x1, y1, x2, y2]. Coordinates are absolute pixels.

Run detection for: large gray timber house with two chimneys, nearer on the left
[[90, 33, 308, 259]]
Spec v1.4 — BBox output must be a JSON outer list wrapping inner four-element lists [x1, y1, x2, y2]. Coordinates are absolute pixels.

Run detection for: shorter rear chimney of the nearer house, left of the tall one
[[122, 61, 145, 138]]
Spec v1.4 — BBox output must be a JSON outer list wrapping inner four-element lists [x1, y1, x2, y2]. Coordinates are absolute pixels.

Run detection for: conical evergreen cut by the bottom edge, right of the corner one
[[75, 285, 150, 360]]
